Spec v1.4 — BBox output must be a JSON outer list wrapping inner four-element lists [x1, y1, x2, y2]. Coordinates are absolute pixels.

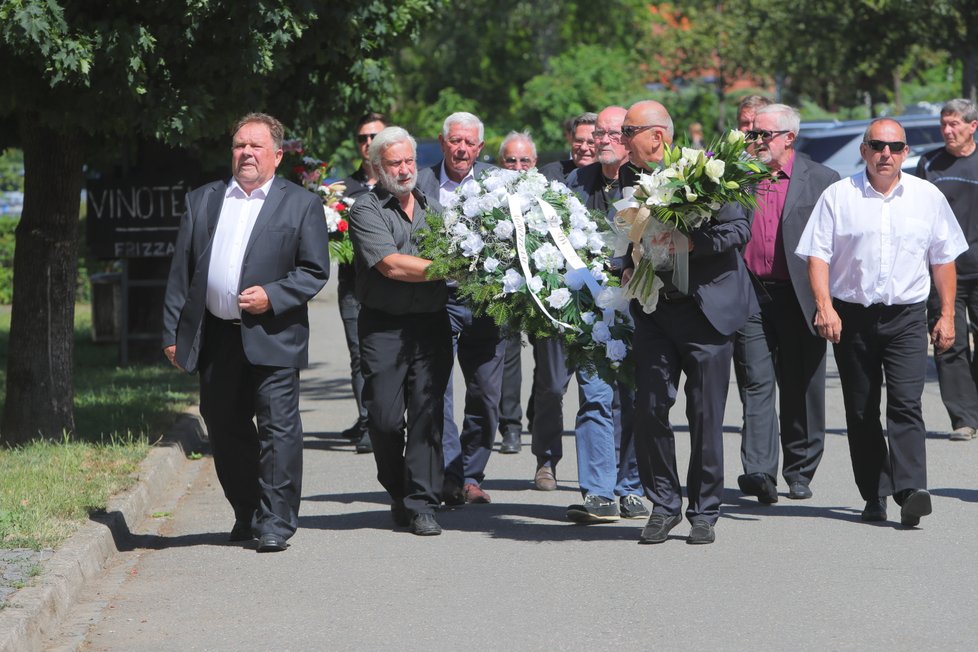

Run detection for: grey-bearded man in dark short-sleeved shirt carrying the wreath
[[350, 127, 452, 536]]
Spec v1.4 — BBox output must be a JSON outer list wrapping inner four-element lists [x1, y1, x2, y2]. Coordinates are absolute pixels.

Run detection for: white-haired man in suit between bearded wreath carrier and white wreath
[[418, 112, 506, 505]]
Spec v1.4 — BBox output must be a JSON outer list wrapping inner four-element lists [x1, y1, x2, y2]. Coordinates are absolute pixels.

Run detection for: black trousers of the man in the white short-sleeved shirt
[[834, 300, 927, 500]]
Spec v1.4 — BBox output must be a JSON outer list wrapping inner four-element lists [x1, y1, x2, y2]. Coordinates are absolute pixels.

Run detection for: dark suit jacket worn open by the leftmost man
[[163, 177, 329, 372]]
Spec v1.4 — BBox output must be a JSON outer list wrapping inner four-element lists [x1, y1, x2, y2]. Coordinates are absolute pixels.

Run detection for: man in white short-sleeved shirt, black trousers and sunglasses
[[795, 118, 968, 527]]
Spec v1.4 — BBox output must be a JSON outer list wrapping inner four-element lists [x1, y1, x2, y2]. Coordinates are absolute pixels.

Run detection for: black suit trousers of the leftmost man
[[199, 315, 302, 538]]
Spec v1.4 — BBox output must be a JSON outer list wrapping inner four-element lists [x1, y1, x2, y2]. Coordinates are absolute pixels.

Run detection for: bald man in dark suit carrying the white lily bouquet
[[619, 101, 758, 544]]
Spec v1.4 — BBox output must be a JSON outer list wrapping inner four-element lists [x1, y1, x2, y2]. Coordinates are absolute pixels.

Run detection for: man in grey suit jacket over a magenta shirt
[[734, 104, 839, 505]]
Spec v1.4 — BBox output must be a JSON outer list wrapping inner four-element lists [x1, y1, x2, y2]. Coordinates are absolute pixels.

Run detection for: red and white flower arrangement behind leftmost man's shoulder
[[282, 140, 353, 264]]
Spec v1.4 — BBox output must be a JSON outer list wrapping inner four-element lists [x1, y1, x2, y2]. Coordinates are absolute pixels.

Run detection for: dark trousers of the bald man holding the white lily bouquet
[[631, 298, 733, 523]]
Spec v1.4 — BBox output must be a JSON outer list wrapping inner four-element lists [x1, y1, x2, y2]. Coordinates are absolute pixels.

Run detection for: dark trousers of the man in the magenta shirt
[[734, 281, 826, 485]]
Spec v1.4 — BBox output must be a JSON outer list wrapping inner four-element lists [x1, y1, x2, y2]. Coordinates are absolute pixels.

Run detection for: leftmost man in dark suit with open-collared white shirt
[[163, 113, 329, 552]]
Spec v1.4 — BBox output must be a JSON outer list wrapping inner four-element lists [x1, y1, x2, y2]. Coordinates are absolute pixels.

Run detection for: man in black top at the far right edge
[[917, 99, 978, 441]]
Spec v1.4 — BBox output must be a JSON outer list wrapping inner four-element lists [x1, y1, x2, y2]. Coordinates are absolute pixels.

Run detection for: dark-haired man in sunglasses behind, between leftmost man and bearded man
[[336, 112, 387, 453]]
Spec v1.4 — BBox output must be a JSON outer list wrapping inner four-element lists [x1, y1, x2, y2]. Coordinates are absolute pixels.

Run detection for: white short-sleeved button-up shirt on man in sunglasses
[[795, 170, 968, 306]]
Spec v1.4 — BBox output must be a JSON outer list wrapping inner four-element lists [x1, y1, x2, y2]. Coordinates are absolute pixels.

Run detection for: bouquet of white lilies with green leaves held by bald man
[[615, 131, 772, 313]]
